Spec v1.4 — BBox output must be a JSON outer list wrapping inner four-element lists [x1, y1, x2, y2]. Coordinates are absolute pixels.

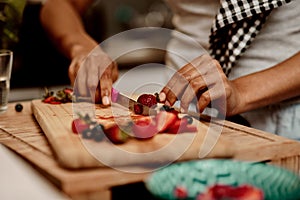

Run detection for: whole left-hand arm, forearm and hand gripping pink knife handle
[[40, 0, 118, 105]]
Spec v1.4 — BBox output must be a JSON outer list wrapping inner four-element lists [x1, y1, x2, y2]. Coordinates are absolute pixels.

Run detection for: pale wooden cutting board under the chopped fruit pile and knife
[[31, 99, 233, 169]]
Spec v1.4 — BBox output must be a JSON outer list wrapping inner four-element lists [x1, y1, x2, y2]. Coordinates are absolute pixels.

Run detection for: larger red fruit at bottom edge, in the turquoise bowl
[[197, 185, 264, 200]]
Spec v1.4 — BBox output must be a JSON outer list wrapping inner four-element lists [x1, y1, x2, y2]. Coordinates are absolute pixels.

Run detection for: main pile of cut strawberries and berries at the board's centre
[[72, 94, 197, 144]]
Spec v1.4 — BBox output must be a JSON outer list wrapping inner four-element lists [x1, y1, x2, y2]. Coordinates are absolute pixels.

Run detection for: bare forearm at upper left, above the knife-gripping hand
[[40, 0, 97, 59]]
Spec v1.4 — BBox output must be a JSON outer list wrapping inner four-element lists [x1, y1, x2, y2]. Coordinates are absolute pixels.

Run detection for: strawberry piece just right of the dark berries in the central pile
[[104, 124, 129, 144]]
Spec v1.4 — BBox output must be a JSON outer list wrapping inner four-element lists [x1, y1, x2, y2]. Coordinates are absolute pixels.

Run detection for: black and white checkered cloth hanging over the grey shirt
[[209, 0, 291, 76]]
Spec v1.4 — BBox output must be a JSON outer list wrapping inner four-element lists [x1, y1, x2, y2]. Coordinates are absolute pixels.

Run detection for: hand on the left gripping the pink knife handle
[[69, 46, 118, 105]]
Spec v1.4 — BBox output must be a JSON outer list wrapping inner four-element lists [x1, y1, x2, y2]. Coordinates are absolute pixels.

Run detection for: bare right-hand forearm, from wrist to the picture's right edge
[[230, 52, 300, 115]]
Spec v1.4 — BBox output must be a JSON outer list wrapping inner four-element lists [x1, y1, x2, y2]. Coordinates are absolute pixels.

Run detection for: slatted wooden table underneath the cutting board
[[0, 102, 300, 199]]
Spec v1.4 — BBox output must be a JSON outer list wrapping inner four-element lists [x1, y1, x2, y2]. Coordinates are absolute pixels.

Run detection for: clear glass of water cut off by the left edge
[[0, 49, 13, 113]]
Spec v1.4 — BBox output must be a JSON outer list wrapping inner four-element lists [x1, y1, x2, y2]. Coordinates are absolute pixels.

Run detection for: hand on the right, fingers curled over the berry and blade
[[159, 55, 240, 115]]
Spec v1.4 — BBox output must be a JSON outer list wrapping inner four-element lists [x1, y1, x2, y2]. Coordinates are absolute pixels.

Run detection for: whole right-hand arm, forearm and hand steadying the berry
[[160, 52, 300, 116]]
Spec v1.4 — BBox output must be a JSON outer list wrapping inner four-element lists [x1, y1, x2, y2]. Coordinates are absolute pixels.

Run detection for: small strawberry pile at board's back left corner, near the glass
[[43, 88, 73, 104]]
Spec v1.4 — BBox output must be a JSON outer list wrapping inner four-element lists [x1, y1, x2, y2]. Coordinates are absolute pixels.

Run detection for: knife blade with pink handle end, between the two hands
[[111, 88, 158, 115]]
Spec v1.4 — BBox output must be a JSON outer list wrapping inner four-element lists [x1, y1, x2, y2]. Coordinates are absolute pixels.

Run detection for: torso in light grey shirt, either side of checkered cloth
[[165, 0, 300, 79]]
